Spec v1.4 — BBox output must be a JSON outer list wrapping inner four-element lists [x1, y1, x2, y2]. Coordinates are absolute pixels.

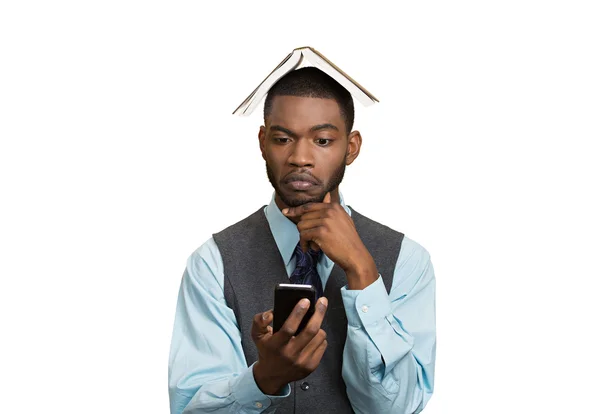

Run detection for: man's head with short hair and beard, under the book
[[258, 68, 362, 208]]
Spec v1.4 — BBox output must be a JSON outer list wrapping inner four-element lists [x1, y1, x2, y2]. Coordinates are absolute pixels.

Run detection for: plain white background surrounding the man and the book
[[0, 1, 600, 414]]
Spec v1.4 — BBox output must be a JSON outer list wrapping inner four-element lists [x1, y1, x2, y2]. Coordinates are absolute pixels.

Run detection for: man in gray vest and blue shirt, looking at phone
[[169, 68, 436, 414]]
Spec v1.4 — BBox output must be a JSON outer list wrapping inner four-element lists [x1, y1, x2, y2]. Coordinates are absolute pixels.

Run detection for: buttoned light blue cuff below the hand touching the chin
[[341, 275, 392, 328]]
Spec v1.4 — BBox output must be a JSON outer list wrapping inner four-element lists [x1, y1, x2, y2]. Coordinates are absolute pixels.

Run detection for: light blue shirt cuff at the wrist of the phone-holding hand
[[233, 364, 291, 413]]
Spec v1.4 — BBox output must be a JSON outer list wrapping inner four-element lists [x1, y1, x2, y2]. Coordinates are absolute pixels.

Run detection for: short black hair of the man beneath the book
[[264, 66, 354, 134]]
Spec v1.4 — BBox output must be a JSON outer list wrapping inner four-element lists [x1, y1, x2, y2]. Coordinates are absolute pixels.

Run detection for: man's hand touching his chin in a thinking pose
[[282, 193, 379, 290]]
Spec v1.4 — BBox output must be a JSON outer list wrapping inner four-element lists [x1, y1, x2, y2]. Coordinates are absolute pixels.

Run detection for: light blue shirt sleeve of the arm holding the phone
[[169, 238, 291, 414]]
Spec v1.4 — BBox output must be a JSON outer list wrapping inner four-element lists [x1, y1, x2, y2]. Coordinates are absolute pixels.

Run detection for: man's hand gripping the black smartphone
[[252, 297, 327, 395]]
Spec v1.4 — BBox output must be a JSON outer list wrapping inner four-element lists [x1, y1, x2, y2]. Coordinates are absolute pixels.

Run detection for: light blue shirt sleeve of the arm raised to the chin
[[342, 237, 436, 414]]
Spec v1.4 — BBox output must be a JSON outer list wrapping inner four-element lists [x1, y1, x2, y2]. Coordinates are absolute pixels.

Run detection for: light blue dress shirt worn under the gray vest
[[169, 194, 436, 414]]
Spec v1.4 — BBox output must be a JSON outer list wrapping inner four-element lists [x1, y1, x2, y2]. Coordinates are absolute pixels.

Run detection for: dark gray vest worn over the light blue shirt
[[213, 207, 404, 414]]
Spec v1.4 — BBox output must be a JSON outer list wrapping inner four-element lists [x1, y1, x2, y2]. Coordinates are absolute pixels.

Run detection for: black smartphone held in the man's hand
[[273, 283, 317, 335]]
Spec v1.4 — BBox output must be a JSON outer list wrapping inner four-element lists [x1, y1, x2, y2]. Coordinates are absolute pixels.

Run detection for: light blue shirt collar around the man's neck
[[265, 192, 351, 265]]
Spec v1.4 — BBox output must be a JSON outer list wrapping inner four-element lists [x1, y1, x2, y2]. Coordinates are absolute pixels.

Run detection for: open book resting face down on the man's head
[[233, 46, 379, 116]]
